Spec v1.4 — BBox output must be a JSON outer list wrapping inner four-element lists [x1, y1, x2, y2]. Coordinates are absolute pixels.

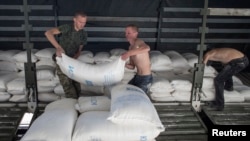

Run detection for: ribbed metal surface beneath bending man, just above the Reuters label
[[203, 103, 250, 125]]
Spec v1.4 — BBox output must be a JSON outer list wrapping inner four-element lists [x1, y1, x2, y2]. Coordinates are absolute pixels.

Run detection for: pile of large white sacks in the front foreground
[[21, 84, 165, 141]]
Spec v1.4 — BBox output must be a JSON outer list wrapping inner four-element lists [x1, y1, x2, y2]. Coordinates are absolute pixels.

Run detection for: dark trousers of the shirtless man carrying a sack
[[128, 74, 153, 94]]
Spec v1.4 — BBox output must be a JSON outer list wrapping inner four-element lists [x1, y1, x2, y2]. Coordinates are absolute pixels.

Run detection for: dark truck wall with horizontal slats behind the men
[[0, 0, 250, 58]]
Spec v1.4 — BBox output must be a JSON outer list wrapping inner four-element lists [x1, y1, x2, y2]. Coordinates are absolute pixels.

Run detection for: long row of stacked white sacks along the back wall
[[0, 48, 250, 102]]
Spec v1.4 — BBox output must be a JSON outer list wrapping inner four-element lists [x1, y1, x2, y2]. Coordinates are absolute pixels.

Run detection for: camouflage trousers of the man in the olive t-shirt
[[56, 65, 81, 99]]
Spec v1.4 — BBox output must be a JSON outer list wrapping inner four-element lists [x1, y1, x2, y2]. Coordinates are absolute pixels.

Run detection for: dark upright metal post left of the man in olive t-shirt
[[21, 0, 38, 113]]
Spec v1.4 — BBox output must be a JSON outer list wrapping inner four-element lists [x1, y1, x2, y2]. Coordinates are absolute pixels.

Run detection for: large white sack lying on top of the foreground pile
[[107, 84, 164, 133]]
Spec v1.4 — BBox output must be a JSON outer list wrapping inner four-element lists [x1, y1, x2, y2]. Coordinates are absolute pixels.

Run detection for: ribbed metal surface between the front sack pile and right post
[[155, 105, 207, 141]]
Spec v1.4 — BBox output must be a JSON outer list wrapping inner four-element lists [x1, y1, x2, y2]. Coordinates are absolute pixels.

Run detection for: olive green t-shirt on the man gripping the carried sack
[[58, 24, 88, 57]]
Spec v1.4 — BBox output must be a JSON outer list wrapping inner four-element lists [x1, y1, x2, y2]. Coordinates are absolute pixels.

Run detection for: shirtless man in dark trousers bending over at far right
[[203, 48, 249, 111]]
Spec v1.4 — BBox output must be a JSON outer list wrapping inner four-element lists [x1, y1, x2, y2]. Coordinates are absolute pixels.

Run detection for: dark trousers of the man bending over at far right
[[214, 56, 249, 106]]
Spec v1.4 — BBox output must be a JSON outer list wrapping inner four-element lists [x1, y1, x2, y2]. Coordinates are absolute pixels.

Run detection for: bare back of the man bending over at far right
[[204, 48, 244, 64]]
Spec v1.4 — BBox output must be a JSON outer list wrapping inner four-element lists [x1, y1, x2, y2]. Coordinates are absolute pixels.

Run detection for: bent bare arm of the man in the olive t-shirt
[[45, 27, 64, 56]]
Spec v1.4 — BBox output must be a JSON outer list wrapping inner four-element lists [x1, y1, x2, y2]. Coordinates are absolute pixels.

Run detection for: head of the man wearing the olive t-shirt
[[73, 11, 87, 31]]
